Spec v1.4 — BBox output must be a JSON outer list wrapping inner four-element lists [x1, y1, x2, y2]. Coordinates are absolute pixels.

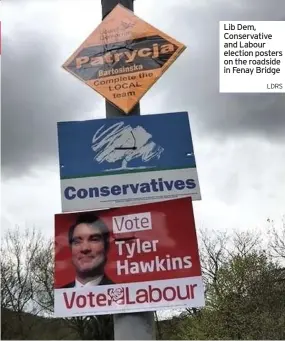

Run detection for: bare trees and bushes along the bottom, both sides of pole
[[1, 219, 285, 340]]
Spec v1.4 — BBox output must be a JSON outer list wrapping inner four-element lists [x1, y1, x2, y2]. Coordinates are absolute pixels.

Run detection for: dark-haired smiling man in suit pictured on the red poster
[[62, 212, 114, 288]]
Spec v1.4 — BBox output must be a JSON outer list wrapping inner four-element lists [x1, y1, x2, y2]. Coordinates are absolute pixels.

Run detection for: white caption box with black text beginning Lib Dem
[[219, 21, 285, 93]]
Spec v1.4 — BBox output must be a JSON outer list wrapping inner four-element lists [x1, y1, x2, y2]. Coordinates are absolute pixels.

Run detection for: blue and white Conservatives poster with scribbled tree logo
[[58, 112, 201, 212]]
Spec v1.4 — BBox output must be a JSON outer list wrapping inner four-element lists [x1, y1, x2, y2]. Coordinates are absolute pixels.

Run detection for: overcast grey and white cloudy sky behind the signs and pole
[[1, 0, 285, 247]]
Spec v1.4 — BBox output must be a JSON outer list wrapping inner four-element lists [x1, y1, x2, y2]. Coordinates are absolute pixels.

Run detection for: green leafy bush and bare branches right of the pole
[[158, 230, 285, 340]]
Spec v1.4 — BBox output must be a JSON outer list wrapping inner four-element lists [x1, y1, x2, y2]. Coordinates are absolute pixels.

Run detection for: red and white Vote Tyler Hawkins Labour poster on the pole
[[54, 198, 205, 317]]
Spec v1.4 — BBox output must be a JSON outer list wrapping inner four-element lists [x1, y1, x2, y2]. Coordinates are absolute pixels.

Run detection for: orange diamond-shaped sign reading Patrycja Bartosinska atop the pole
[[63, 5, 186, 114]]
